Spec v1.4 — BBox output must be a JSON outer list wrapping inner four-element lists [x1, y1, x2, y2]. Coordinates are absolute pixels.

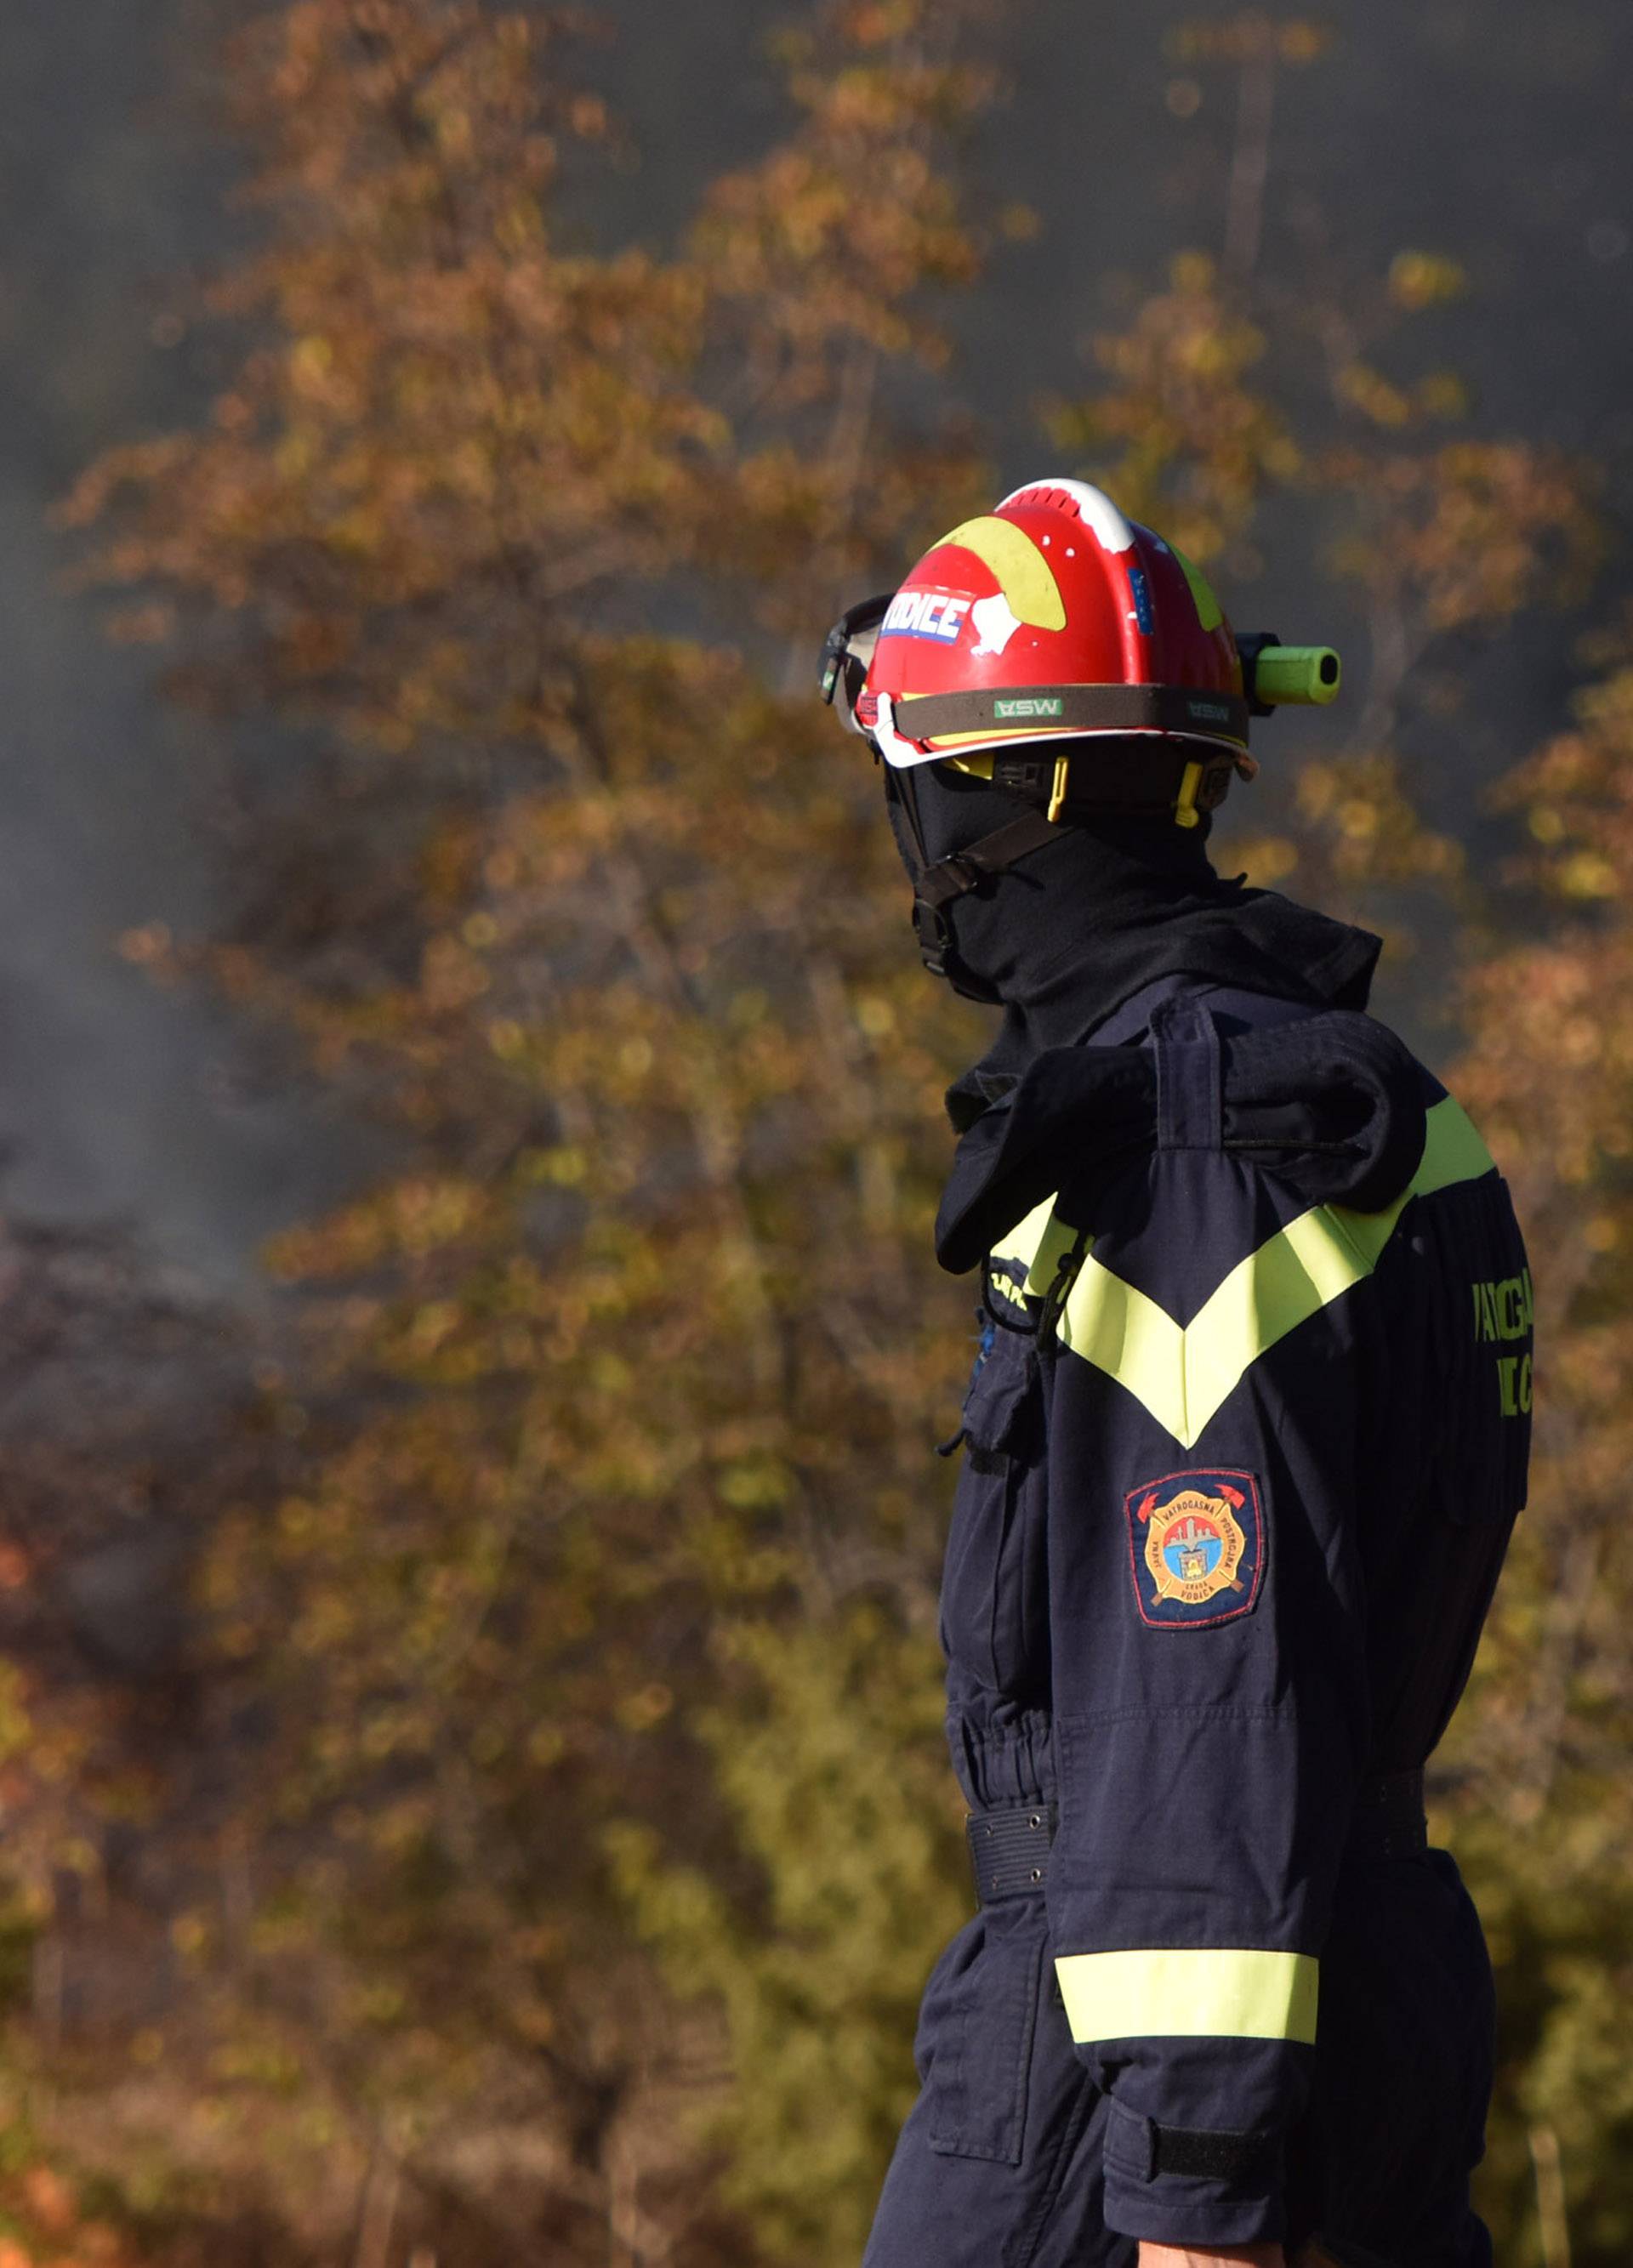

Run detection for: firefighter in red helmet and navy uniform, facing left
[[823, 479, 1531, 2268]]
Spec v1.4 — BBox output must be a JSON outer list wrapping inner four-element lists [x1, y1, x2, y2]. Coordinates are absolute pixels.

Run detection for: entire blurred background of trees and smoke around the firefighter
[[0, 0, 1633, 2268]]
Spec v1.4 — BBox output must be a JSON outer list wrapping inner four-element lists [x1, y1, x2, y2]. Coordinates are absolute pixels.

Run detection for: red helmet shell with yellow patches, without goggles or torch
[[855, 480, 1252, 821]]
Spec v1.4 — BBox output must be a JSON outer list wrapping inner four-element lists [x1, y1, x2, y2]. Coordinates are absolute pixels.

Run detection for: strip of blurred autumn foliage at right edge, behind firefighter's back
[[1452, 637, 1633, 2268]]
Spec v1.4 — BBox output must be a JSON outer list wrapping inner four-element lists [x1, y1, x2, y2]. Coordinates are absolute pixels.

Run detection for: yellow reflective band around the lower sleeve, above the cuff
[[1055, 1946, 1320, 2048]]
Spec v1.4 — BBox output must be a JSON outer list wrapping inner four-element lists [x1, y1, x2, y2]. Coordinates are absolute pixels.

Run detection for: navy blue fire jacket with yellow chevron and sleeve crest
[[916, 1000, 1531, 2257]]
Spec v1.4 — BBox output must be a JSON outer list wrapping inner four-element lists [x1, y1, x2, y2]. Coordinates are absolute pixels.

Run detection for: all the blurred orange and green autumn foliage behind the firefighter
[[0, 0, 1633, 2268]]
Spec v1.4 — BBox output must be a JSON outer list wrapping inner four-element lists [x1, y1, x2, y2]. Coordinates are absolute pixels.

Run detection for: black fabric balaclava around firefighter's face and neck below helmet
[[891, 748, 1381, 1129]]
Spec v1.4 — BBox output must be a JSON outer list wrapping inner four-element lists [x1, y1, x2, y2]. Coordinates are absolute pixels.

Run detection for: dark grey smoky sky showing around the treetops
[[0, 0, 1633, 1295]]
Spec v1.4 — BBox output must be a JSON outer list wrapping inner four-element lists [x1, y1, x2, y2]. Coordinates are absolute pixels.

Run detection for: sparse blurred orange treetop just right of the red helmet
[[1048, 242, 1599, 957]]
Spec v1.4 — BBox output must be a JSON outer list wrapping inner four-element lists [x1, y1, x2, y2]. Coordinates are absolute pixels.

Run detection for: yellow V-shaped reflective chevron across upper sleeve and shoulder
[[996, 1095, 1493, 1449]]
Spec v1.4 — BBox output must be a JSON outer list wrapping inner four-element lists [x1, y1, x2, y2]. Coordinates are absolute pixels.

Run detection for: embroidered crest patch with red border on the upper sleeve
[[1125, 1468, 1263, 1631]]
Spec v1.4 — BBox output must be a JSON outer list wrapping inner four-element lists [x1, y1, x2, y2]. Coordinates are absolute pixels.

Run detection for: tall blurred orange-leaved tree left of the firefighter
[[72, 0, 984, 2259]]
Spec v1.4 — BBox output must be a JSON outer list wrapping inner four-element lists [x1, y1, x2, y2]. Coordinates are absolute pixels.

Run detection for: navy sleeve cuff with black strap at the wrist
[[1105, 2100, 1286, 2250]]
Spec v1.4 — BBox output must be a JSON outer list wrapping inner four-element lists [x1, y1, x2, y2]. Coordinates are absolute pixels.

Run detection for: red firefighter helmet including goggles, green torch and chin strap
[[821, 480, 1340, 980]]
